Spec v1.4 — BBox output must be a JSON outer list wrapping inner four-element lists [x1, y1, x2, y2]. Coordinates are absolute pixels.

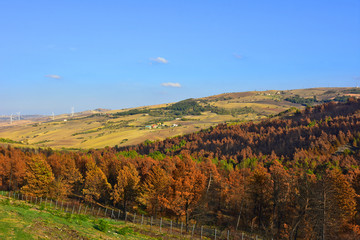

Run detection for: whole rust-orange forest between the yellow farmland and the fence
[[0, 98, 360, 239]]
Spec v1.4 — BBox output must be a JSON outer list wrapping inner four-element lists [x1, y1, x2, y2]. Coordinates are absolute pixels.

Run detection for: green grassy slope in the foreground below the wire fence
[[0, 197, 173, 239]]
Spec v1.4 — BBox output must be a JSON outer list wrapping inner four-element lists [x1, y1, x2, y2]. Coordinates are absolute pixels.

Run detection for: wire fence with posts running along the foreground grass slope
[[0, 191, 264, 240]]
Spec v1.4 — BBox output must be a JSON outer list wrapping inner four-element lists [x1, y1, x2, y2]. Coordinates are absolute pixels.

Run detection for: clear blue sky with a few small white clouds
[[0, 0, 360, 114]]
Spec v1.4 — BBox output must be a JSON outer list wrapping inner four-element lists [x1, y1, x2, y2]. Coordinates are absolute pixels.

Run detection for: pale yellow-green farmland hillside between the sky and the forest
[[0, 88, 360, 149]]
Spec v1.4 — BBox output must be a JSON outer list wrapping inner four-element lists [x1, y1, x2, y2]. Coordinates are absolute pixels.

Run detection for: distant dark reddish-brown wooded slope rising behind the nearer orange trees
[[125, 95, 360, 164]]
